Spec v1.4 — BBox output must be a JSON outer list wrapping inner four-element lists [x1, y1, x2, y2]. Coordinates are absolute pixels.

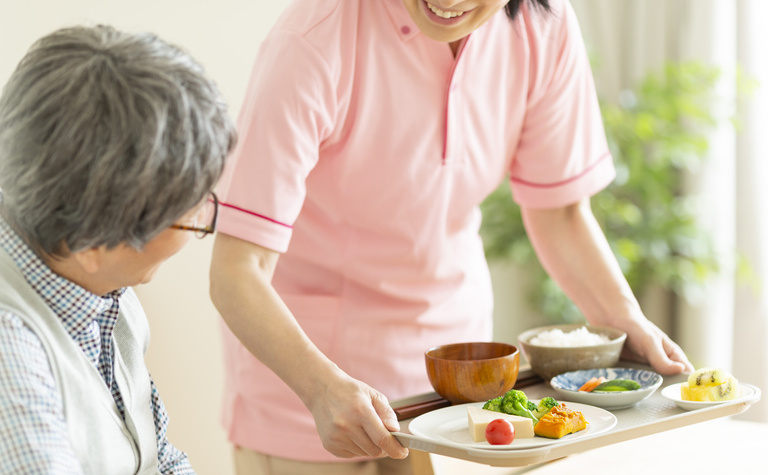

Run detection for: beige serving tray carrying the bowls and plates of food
[[392, 365, 761, 467]]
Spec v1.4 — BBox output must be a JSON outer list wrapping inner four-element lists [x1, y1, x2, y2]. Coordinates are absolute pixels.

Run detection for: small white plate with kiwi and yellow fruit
[[661, 368, 760, 411]]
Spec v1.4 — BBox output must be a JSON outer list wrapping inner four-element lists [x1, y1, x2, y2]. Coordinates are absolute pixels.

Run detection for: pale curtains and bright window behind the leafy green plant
[[571, 0, 768, 422]]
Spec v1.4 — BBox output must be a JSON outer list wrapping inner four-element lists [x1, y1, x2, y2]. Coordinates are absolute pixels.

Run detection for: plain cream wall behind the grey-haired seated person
[[0, 0, 288, 475]]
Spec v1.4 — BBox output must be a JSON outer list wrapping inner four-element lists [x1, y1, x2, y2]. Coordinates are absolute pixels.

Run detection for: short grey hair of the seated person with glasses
[[0, 26, 235, 256]]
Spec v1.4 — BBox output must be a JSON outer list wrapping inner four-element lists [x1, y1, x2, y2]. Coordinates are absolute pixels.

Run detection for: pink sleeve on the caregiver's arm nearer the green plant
[[510, 1, 615, 208]]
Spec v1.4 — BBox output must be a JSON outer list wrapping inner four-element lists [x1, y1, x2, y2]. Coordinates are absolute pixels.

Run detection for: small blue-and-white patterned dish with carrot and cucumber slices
[[549, 368, 663, 410]]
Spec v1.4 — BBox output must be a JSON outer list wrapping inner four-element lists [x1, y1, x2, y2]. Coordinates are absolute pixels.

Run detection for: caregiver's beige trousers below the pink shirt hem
[[234, 447, 413, 475]]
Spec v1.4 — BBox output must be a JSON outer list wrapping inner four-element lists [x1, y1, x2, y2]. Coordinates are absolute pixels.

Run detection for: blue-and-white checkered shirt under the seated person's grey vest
[[0, 218, 194, 474]]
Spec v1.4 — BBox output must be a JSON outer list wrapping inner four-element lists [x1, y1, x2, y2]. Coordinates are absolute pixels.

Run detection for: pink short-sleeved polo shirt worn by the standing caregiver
[[219, 0, 614, 461]]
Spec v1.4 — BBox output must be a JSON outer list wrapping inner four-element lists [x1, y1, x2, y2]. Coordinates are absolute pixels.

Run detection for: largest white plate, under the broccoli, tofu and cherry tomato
[[408, 401, 616, 450]]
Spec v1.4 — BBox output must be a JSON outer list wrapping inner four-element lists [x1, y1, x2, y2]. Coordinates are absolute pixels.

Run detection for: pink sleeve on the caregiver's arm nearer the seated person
[[217, 31, 335, 252]]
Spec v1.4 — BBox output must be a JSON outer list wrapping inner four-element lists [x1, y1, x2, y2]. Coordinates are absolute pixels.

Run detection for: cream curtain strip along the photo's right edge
[[733, 0, 768, 422]]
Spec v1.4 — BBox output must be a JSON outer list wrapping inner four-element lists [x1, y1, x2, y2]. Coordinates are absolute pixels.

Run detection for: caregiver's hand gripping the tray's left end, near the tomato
[[305, 371, 408, 459]]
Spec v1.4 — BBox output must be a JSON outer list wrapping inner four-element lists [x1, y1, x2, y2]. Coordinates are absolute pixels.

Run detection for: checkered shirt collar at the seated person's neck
[[0, 217, 118, 338]]
